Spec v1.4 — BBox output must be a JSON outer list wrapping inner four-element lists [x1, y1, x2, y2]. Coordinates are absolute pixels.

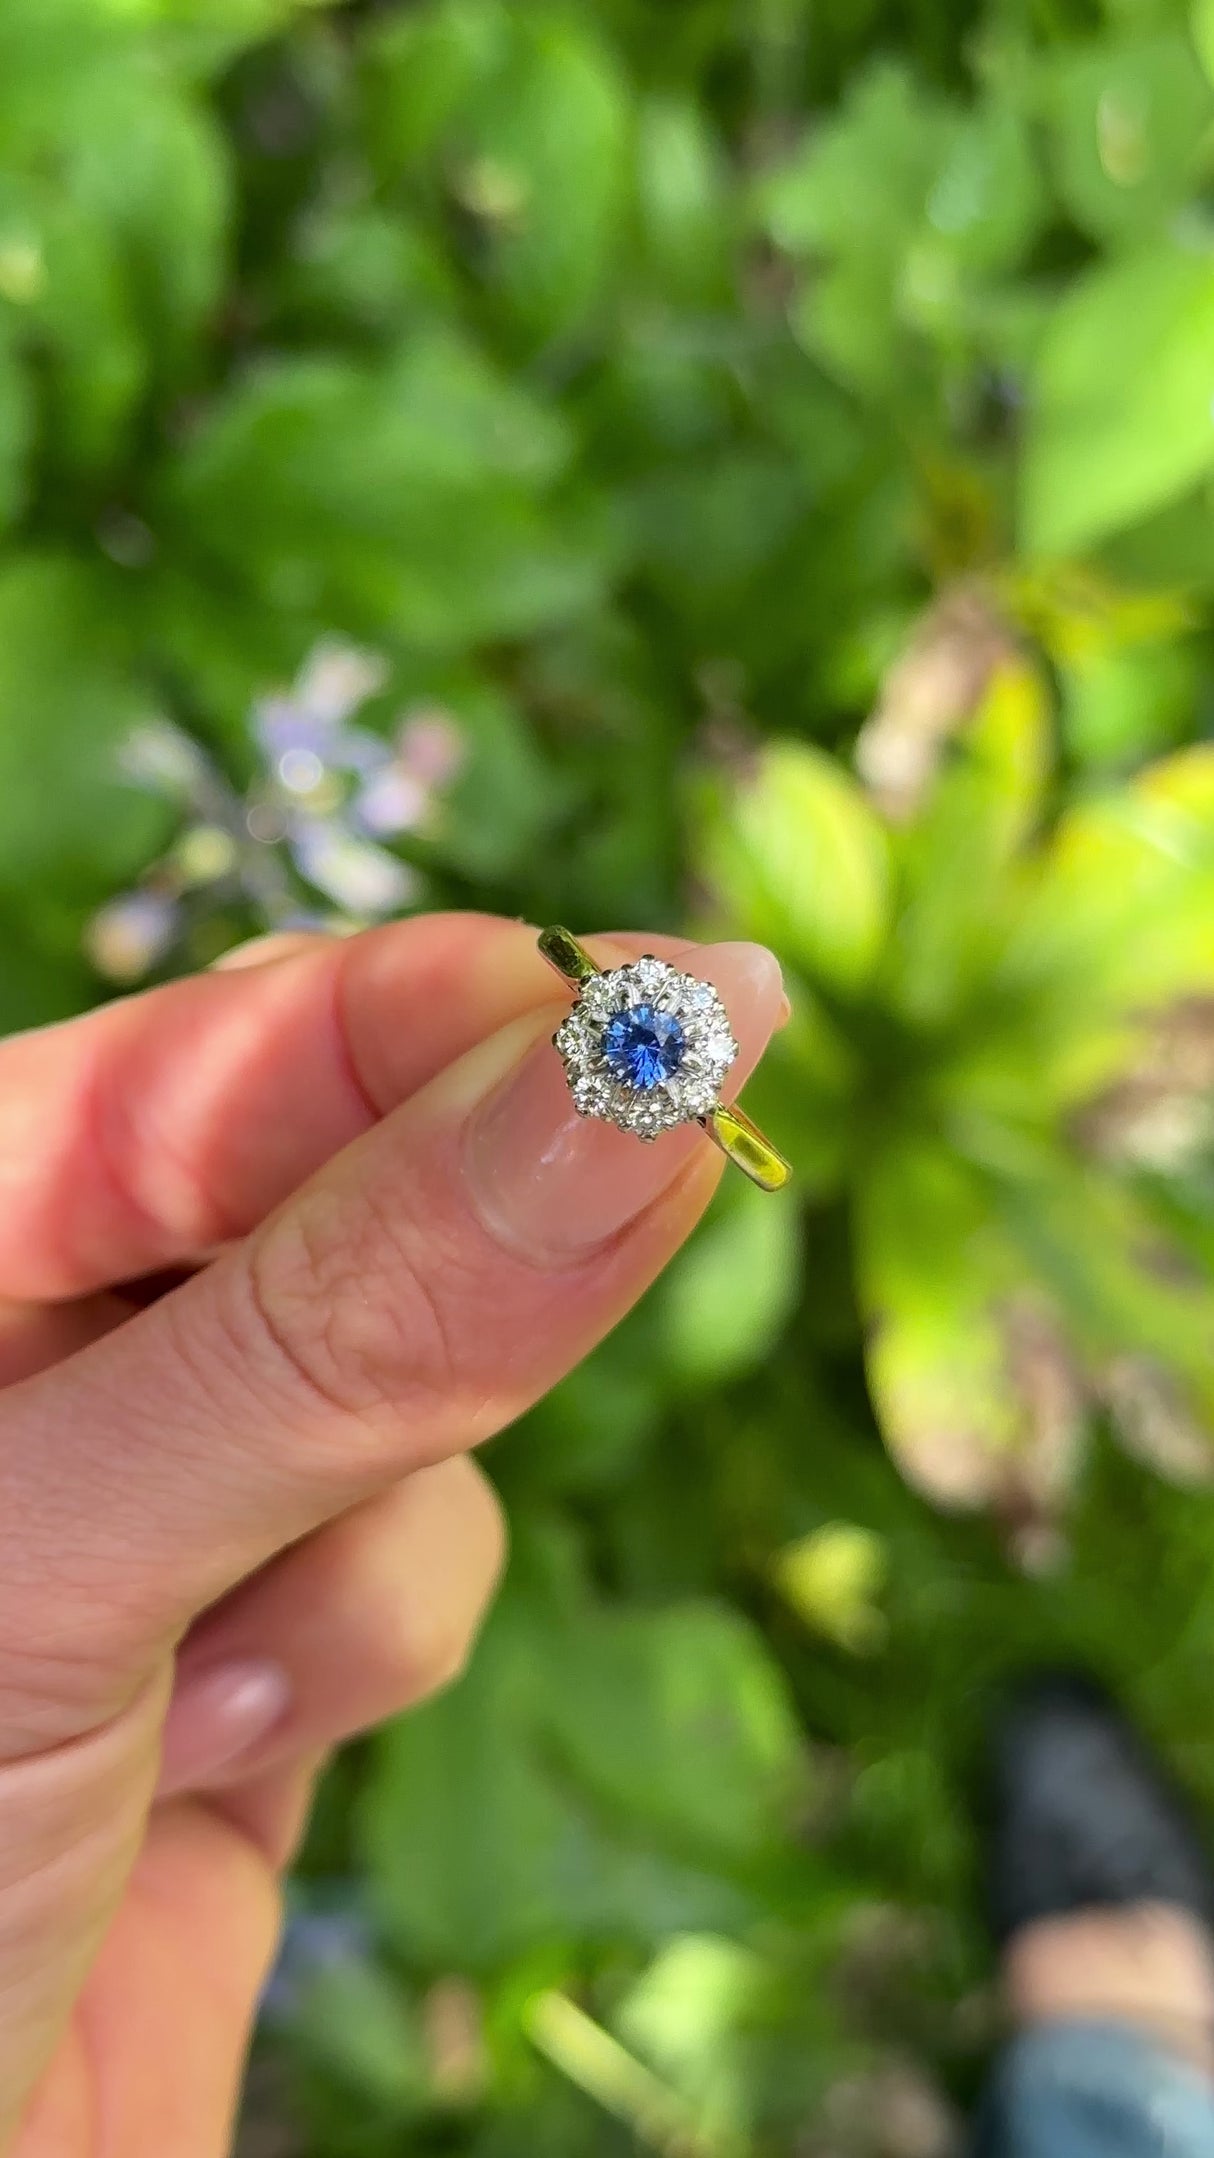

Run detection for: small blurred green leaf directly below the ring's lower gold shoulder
[[660, 1180, 800, 1385]]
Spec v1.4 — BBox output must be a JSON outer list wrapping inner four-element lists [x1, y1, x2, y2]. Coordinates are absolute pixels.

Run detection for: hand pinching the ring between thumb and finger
[[0, 915, 781, 2158]]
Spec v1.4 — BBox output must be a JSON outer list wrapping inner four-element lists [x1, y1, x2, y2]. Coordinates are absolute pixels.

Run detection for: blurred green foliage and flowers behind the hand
[[0, 0, 1214, 2158]]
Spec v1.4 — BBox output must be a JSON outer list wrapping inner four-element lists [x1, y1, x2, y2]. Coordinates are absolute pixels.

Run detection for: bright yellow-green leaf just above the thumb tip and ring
[[699, 740, 891, 993]]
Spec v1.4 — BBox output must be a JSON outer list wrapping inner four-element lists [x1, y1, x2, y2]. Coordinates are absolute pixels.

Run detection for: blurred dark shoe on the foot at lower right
[[990, 1672, 1214, 1942]]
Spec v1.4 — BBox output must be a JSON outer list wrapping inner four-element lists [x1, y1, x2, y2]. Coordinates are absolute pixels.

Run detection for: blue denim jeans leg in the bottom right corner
[[975, 2022, 1214, 2158]]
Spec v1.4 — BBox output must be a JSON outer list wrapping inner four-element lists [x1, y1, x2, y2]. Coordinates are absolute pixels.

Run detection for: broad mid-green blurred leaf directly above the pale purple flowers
[[162, 332, 606, 650]]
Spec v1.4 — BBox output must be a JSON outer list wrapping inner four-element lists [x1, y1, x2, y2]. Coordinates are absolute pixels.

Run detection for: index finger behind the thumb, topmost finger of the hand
[[0, 913, 546, 1299]]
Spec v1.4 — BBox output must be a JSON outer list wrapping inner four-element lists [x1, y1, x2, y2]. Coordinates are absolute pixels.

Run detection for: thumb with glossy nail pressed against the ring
[[0, 945, 783, 1744]]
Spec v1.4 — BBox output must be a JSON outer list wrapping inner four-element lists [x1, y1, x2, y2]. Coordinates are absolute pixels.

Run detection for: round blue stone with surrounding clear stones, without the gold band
[[554, 954, 737, 1139]]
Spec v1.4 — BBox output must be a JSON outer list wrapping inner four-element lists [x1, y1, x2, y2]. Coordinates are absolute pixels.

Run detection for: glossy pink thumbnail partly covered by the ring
[[466, 943, 783, 1265]]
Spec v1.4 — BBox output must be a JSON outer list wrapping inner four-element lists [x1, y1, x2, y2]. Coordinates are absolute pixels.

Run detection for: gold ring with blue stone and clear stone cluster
[[539, 928, 791, 1191]]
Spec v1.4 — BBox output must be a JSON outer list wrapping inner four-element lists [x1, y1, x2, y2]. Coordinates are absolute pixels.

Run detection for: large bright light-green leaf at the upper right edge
[[1020, 242, 1214, 555]]
